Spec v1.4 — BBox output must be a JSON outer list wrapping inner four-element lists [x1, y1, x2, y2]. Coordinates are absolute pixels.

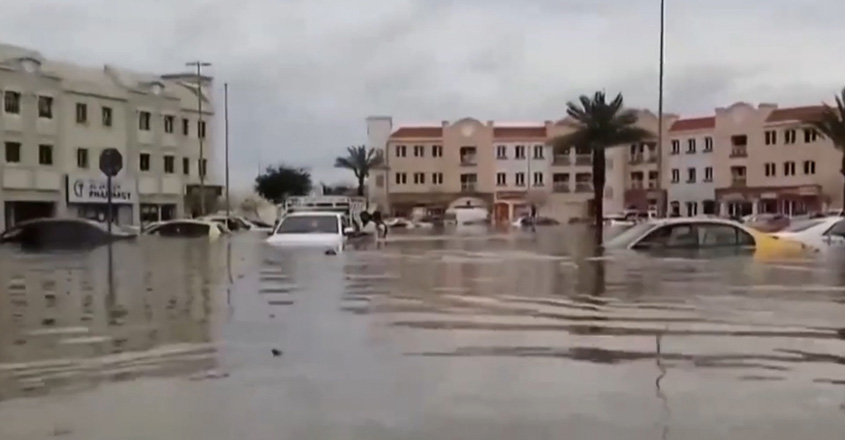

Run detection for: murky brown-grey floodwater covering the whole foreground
[[0, 227, 845, 440]]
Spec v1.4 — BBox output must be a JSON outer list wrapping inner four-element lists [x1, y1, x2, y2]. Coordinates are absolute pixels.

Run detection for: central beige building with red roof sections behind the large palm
[[367, 112, 665, 222]]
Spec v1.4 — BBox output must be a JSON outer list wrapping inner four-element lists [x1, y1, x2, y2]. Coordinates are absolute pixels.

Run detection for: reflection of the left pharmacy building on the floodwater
[[0, 240, 244, 399]]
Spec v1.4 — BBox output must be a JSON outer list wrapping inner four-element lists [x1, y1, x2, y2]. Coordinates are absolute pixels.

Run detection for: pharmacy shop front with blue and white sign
[[67, 175, 138, 225]]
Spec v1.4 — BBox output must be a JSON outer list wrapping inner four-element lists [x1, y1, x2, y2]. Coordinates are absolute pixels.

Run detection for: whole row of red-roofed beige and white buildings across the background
[[367, 103, 843, 222]]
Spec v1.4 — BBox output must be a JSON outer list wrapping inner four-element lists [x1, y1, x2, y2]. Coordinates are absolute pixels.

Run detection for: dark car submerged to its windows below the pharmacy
[[0, 218, 137, 249]]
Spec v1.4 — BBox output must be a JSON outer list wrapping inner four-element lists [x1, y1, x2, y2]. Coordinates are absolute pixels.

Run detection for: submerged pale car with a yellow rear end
[[605, 217, 810, 257]]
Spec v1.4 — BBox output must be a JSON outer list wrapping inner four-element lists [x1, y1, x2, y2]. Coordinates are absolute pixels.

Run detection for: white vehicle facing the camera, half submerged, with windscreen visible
[[266, 211, 354, 252]]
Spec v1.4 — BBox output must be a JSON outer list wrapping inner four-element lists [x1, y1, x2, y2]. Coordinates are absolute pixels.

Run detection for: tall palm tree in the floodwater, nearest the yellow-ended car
[[548, 92, 654, 248]]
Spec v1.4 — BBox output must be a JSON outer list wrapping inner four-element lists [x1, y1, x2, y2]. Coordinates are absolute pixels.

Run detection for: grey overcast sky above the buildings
[[0, 0, 845, 191]]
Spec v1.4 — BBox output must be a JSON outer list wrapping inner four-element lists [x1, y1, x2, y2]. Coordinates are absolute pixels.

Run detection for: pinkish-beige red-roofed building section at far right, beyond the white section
[[713, 103, 842, 215]]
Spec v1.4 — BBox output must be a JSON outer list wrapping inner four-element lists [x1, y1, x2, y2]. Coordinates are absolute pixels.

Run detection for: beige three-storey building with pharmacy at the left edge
[[0, 45, 219, 229]]
